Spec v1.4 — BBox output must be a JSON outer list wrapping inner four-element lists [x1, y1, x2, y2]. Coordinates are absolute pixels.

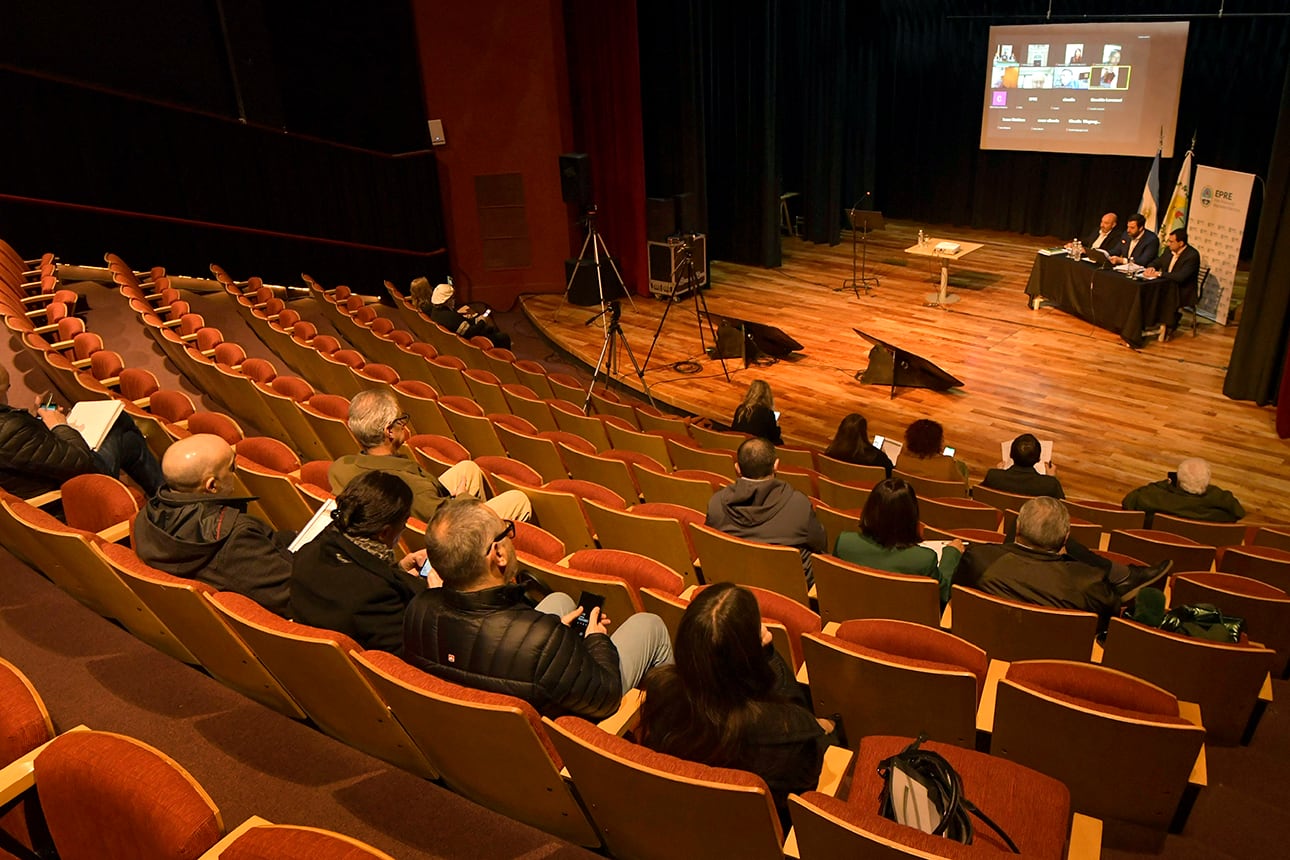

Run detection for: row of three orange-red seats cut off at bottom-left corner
[[0, 659, 392, 860]]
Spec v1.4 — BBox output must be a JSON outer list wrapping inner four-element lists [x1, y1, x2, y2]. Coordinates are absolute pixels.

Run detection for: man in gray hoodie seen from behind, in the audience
[[706, 438, 828, 587]]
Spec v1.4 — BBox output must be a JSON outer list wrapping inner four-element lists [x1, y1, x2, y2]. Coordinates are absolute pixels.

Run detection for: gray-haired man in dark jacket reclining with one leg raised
[[955, 496, 1173, 628]]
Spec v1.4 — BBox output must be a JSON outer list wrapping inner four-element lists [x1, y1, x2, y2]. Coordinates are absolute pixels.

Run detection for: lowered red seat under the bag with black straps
[[792, 735, 1071, 860]]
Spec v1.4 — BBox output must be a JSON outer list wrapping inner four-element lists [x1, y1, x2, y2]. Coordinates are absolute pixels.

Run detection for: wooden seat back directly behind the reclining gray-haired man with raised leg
[[949, 585, 1098, 661]]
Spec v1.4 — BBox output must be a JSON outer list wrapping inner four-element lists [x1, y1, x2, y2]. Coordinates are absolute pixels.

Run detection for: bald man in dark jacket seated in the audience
[[134, 433, 295, 616]]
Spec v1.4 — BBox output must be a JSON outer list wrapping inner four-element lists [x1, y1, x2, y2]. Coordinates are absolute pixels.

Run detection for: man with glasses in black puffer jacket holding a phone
[[404, 496, 672, 719]]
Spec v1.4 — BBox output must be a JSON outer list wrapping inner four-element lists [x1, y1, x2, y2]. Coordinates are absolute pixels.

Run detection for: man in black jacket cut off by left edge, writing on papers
[[0, 365, 161, 498]]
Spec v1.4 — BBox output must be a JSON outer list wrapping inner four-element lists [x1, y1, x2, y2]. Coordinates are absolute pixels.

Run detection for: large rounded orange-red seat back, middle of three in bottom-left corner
[[36, 731, 223, 860]]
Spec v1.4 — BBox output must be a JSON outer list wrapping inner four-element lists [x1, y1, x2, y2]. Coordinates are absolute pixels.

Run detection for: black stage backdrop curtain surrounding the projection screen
[[640, 0, 1290, 254]]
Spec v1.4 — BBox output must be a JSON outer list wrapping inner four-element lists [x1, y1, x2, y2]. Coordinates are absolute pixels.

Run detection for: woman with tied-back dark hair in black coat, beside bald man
[[290, 472, 426, 654]]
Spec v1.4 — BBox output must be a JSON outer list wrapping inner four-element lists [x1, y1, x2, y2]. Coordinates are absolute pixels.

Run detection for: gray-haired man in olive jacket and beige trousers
[[328, 388, 533, 522]]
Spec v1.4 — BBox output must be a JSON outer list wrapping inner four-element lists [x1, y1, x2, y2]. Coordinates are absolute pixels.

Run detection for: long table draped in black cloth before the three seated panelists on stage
[[1026, 254, 1180, 347]]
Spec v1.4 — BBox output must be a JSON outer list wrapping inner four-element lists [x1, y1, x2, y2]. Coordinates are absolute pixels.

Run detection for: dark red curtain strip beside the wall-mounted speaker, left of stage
[[567, 0, 649, 295]]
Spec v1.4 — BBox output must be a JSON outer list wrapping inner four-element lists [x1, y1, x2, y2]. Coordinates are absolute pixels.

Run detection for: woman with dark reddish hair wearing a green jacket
[[833, 478, 964, 606]]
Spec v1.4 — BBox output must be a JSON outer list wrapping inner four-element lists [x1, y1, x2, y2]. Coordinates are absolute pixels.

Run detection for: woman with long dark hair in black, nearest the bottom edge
[[637, 583, 833, 821]]
